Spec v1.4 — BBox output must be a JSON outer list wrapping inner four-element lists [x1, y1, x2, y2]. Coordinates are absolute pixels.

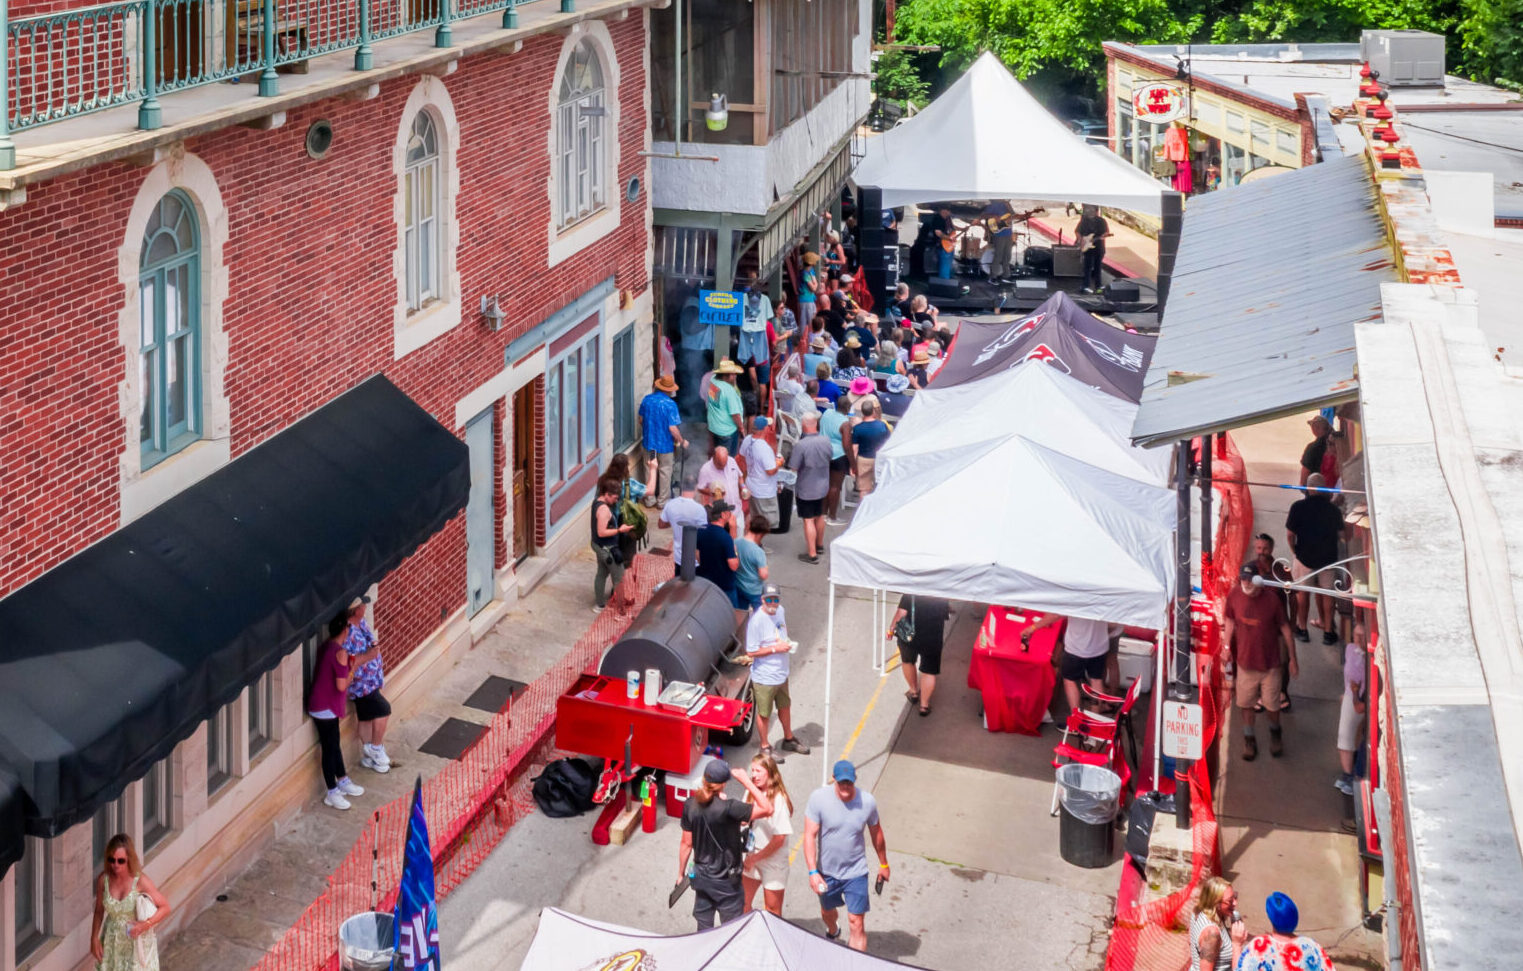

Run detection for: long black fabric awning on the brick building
[[0, 376, 471, 872]]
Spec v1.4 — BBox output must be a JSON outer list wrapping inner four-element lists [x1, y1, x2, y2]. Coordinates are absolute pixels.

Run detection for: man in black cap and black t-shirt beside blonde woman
[[678, 758, 772, 930]]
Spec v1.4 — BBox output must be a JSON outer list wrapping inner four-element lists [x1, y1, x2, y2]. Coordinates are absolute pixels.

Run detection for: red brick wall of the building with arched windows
[[0, 17, 647, 669]]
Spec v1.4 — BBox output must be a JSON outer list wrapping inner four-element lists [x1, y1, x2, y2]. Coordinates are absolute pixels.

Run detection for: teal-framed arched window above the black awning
[[137, 189, 201, 469]]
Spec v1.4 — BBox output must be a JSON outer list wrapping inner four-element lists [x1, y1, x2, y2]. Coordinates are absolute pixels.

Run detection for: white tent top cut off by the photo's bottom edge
[[519, 907, 905, 971]]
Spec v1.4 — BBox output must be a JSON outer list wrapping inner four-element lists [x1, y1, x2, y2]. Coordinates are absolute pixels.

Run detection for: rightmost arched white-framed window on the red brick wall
[[556, 38, 608, 227]]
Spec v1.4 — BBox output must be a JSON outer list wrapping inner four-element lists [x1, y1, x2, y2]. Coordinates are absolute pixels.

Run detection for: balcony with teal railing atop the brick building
[[0, 0, 648, 182]]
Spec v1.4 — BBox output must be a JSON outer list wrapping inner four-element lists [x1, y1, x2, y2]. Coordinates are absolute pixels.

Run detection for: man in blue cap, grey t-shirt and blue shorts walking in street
[[804, 759, 888, 951]]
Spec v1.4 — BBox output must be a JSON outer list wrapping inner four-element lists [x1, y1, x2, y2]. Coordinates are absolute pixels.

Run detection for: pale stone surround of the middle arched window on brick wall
[[391, 75, 461, 361]]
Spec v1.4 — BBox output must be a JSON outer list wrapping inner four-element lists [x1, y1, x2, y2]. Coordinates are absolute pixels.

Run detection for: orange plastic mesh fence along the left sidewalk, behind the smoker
[[254, 554, 672, 971]]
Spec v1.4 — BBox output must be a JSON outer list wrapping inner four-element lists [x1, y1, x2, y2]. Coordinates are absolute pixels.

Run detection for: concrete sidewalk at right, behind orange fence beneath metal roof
[[1217, 414, 1384, 968]]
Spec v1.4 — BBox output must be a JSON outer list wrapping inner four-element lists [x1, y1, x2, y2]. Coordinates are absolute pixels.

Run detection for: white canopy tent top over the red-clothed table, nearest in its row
[[830, 435, 1174, 627]]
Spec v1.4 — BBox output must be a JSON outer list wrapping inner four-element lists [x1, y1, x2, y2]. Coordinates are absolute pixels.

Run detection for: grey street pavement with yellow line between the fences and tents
[[440, 514, 1119, 971]]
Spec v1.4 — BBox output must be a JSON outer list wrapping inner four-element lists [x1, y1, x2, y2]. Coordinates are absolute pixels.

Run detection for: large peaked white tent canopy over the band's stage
[[851, 52, 1165, 216]]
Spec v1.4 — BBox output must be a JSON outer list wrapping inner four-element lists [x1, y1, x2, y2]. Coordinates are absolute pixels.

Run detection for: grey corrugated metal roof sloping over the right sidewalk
[[1132, 157, 1397, 444]]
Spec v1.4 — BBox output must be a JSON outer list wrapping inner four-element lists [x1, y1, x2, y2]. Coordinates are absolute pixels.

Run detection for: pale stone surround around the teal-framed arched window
[[117, 154, 231, 525]]
